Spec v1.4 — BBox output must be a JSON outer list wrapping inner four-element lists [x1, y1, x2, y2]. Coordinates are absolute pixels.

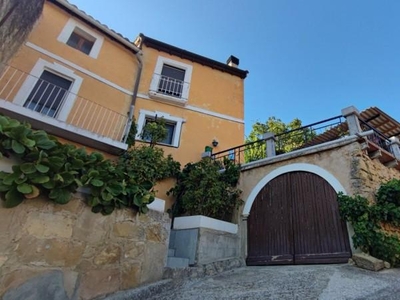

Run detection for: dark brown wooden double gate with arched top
[[246, 172, 351, 265]]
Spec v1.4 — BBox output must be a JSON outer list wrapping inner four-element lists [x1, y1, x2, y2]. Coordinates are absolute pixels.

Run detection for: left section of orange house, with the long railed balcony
[[0, 0, 139, 154]]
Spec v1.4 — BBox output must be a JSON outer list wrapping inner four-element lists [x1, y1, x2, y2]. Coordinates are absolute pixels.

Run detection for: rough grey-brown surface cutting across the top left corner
[[0, 0, 45, 72]]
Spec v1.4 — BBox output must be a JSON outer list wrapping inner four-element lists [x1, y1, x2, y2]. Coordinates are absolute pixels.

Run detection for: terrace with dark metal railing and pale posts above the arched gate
[[211, 107, 400, 171]]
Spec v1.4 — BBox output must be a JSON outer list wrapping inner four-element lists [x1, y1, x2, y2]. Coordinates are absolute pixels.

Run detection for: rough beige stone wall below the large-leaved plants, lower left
[[0, 195, 170, 299]]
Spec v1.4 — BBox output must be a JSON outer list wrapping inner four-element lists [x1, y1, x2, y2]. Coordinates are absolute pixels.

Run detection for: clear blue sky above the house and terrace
[[70, 0, 400, 134]]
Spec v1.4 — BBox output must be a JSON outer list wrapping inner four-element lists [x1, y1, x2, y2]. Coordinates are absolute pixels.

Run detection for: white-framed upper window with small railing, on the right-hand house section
[[150, 56, 193, 103]]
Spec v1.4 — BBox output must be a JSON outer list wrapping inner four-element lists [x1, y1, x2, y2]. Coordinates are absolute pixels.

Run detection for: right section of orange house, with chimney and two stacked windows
[[135, 34, 248, 165]]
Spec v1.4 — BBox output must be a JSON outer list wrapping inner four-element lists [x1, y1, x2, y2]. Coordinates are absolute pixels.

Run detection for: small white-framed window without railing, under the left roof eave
[[57, 19, 104, 58]]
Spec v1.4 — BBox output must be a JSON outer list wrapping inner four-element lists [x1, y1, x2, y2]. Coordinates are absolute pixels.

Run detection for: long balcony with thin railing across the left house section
[[0, 66, 128, 154]]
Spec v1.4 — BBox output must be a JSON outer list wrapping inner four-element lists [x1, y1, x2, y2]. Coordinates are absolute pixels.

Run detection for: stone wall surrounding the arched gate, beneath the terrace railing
[[237, 139, 400, 257]]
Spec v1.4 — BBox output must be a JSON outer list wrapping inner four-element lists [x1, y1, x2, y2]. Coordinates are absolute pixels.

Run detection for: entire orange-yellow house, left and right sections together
[[0, 0, 248, 210]]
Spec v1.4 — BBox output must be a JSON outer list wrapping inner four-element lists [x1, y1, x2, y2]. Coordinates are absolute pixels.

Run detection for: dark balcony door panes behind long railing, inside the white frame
[[24, 70, 72, 118]]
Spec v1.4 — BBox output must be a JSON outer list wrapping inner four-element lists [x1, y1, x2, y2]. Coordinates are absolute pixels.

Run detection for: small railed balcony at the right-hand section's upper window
[[149, 74, 190, 105]]
